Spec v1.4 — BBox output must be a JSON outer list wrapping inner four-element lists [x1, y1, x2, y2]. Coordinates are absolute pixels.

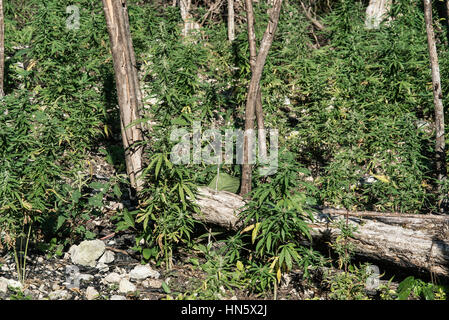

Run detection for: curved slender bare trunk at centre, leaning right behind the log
[[240, 0, 282, 195]]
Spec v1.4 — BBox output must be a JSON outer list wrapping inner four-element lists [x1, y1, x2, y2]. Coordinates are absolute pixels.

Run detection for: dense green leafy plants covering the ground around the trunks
[[0, 0, 449, 299]]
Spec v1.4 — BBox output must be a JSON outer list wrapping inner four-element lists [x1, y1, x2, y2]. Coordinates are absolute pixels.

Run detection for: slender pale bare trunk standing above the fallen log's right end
[[424, 0, 446, 191]]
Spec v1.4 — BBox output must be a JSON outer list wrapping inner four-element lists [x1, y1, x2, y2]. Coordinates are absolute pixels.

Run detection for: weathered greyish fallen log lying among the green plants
[[196, 187, 449, 277]]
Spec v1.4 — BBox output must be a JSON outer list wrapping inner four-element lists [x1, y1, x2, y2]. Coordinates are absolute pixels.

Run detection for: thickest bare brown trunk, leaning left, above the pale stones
[[103, 0, 143, 191]]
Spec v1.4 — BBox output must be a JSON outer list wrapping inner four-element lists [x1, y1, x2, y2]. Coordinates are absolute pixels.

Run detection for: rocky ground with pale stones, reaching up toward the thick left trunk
[[0, 151, 378, 300]]
